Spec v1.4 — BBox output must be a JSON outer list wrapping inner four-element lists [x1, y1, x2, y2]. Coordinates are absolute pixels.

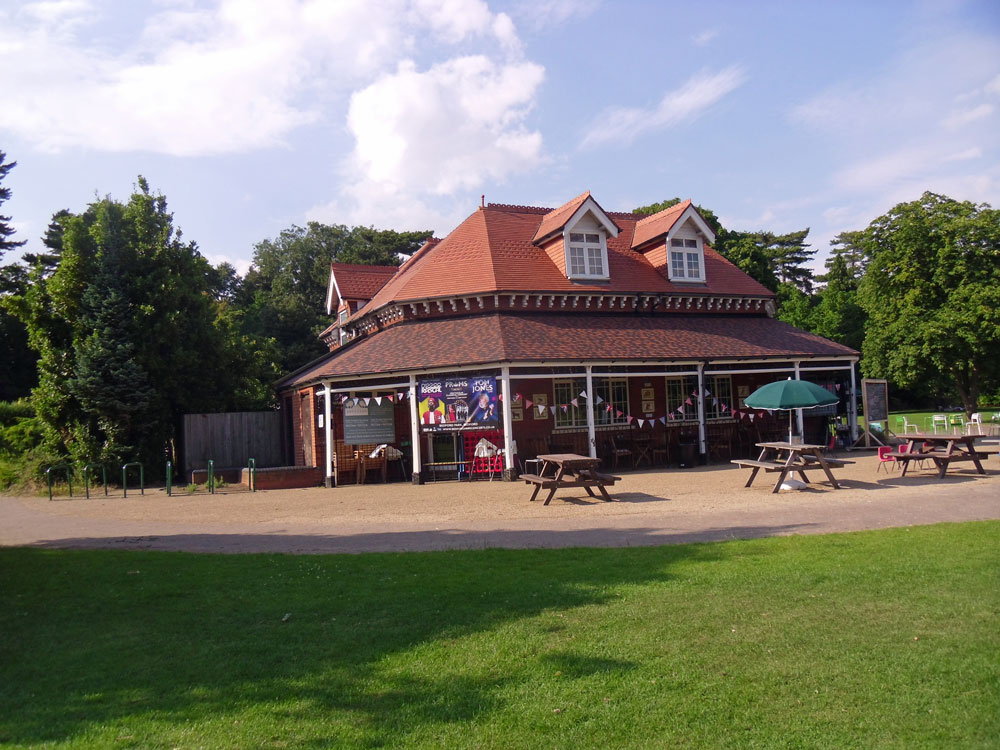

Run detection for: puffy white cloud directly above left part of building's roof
[[328, 55, 544, 223]]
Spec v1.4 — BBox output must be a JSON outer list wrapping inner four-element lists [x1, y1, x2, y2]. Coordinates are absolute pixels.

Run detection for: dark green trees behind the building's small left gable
[[242, 222, 431, 372]]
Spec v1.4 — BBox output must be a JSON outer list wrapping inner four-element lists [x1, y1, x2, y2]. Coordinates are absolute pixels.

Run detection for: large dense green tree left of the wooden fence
[[10, 178, 276, 464]]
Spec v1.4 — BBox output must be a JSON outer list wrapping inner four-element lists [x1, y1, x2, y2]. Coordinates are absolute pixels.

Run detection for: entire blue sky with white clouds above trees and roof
[[0, 0, 1000, 272]]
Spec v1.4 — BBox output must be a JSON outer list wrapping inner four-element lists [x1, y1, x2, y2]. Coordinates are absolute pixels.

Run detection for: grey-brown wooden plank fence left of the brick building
[[183, 411, 284, 474]]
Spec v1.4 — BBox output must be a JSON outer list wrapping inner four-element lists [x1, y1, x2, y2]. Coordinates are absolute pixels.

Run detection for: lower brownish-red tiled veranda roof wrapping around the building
[[280, 313, 857, 387]]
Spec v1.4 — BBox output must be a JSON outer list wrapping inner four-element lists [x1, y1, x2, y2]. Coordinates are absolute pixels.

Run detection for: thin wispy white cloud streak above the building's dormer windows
[[580, 66, 746, 148]]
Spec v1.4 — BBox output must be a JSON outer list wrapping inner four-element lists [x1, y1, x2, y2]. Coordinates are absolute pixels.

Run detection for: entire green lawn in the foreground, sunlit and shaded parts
[[0, 522, 1000, 748]]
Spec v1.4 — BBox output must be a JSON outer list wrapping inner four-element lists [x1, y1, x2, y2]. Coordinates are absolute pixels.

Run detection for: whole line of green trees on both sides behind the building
[[0, 152, 1000, 476]]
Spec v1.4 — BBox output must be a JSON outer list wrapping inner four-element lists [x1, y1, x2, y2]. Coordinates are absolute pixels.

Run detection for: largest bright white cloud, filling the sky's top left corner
[[0, 0, 519, 156]]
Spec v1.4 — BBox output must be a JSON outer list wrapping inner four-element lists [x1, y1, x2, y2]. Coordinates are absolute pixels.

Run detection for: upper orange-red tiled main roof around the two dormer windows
[[361, 200, 774, 315]]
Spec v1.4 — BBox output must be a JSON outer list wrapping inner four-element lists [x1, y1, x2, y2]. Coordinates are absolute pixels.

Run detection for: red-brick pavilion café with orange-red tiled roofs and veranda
[[279, 192, 858, 483]]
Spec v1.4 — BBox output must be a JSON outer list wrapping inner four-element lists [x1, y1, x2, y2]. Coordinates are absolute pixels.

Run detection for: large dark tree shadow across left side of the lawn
[[0, 537, 784, 746]]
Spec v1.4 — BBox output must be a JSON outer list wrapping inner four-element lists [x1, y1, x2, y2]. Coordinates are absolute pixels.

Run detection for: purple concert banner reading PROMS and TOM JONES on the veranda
[[417, 375, 500, 432]]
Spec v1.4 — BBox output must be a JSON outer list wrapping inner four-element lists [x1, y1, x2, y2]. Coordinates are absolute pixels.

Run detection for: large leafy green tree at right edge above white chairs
[[858, 192, 1000, 414]]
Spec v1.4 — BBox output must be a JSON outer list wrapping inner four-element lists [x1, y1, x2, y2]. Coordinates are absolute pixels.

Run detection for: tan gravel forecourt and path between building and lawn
[[0, 454, 1000, 553]]
